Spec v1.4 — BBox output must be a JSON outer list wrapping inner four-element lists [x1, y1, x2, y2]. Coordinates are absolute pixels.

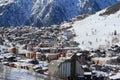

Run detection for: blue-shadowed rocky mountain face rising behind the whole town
[[0, 0, 119, 26]]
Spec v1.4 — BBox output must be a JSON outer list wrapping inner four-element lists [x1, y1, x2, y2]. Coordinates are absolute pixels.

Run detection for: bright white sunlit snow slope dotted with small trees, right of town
[[64, 3, 120, 49]]
